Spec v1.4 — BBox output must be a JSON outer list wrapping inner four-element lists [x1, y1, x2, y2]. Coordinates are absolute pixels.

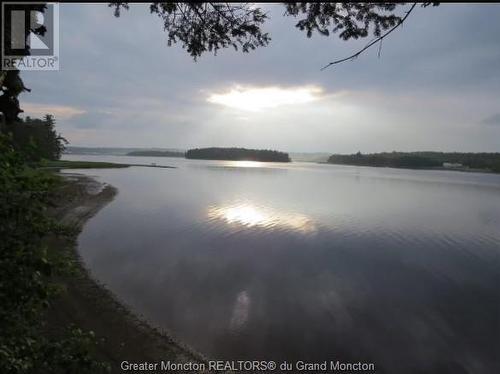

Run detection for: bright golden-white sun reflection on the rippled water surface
[[208, 203, 317, 233]]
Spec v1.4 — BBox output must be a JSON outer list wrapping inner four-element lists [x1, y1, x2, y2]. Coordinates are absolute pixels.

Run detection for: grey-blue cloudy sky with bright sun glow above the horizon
[[21, 4, 500, 153]]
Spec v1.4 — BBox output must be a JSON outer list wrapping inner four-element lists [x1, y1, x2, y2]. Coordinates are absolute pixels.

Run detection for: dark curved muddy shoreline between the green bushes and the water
[[46, 173, 207, 373]]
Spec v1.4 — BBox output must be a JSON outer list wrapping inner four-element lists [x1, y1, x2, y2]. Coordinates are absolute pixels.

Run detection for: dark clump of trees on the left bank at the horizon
[[7, 114, 68, 161]]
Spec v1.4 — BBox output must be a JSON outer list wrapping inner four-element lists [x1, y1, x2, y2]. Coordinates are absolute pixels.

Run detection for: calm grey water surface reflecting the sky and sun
[[62, 156, 500, 374]]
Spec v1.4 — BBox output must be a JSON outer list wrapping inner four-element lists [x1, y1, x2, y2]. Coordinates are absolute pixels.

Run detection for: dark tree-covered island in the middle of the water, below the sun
[[186, 147, 291, 162]]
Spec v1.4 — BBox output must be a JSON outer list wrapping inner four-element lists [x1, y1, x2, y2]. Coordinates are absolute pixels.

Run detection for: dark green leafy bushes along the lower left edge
[[0, 135, 104, 374]]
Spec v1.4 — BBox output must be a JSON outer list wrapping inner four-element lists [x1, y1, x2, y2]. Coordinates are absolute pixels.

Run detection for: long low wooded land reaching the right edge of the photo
[[328, 152, 500, 173]]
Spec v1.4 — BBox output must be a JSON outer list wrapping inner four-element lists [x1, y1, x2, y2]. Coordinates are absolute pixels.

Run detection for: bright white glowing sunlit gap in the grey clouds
[[207, 86, 323, 111]]
